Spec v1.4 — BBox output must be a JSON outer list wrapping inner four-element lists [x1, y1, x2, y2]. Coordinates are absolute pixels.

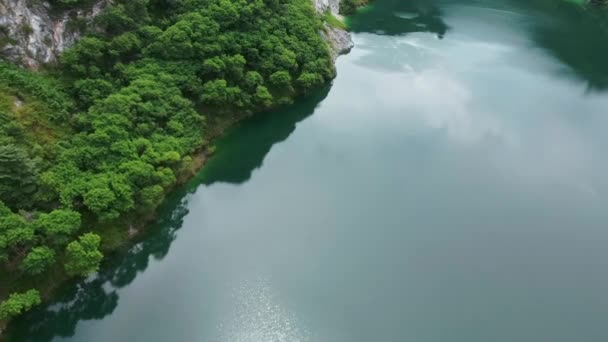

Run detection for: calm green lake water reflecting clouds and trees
[[11, 0, 608, 342]]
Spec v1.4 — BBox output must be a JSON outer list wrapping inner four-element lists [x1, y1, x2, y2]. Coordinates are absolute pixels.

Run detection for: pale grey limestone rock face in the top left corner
[[0, 0, 110, 68]]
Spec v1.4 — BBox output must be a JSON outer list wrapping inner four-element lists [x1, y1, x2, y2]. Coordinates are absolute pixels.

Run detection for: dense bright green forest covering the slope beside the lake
[[0, 0, 334, 320]]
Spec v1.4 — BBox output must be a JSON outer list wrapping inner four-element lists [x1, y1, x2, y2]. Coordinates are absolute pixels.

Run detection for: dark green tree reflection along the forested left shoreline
[[7, 86, 330, 341]]
